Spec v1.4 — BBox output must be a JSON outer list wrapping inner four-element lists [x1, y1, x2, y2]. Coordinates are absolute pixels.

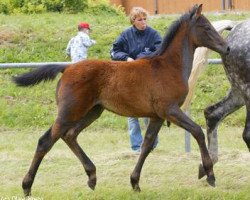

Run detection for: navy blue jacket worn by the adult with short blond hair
[[110, 26, 162, 61]]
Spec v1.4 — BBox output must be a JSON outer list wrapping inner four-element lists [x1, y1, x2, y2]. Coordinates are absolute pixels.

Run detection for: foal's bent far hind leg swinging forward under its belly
[[62, 105, 104, 190]]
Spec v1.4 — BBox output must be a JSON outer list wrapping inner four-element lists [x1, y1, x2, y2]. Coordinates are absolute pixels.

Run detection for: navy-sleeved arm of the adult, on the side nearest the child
[[110, 36, 129, 61]]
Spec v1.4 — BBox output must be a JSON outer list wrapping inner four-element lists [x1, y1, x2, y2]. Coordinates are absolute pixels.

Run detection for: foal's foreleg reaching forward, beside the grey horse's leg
[[167, 105, 215, 186]]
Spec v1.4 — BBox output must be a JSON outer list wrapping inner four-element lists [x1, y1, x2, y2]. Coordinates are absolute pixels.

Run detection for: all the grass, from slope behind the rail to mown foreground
[[0, 10, 250, 200]]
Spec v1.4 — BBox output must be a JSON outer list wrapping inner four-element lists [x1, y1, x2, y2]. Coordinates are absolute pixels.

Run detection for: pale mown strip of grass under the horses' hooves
[[0, 127, 250, 200]]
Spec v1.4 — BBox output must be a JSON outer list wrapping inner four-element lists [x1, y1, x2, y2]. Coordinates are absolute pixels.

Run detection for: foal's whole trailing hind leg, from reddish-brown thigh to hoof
[[23, 88, 98, 196]]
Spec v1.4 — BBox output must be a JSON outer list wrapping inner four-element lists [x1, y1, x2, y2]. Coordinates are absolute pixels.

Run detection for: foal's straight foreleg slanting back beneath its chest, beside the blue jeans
[[130, 118, 164, 191]]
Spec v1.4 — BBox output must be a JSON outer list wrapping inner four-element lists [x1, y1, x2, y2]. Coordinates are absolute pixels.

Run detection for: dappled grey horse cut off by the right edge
[[199, 20, 250, 177]]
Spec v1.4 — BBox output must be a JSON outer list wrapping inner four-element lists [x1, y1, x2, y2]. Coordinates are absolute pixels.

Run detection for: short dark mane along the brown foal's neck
[[149, 5, 198, 58]]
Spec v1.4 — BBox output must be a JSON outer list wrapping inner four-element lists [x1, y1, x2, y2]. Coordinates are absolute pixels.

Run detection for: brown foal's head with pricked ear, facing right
[[189, 4, 230, 54]]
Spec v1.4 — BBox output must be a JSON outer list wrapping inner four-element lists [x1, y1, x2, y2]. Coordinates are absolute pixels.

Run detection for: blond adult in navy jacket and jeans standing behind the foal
[[110, 7, 162, 152]]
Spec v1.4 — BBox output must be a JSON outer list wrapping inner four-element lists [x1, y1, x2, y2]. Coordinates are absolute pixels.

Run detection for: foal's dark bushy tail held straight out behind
[[13, 64, 67, 87]]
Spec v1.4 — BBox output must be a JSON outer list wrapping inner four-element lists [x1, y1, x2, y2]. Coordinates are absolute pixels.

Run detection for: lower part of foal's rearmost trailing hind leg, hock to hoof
[[22, 128, 60, 196]]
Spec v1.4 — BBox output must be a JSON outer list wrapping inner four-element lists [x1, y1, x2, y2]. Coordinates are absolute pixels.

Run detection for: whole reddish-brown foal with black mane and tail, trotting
[[14, 5, 229, 195]]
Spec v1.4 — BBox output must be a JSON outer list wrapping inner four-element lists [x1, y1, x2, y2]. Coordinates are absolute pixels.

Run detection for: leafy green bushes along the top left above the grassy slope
[[0, 0, 124, 15]]
